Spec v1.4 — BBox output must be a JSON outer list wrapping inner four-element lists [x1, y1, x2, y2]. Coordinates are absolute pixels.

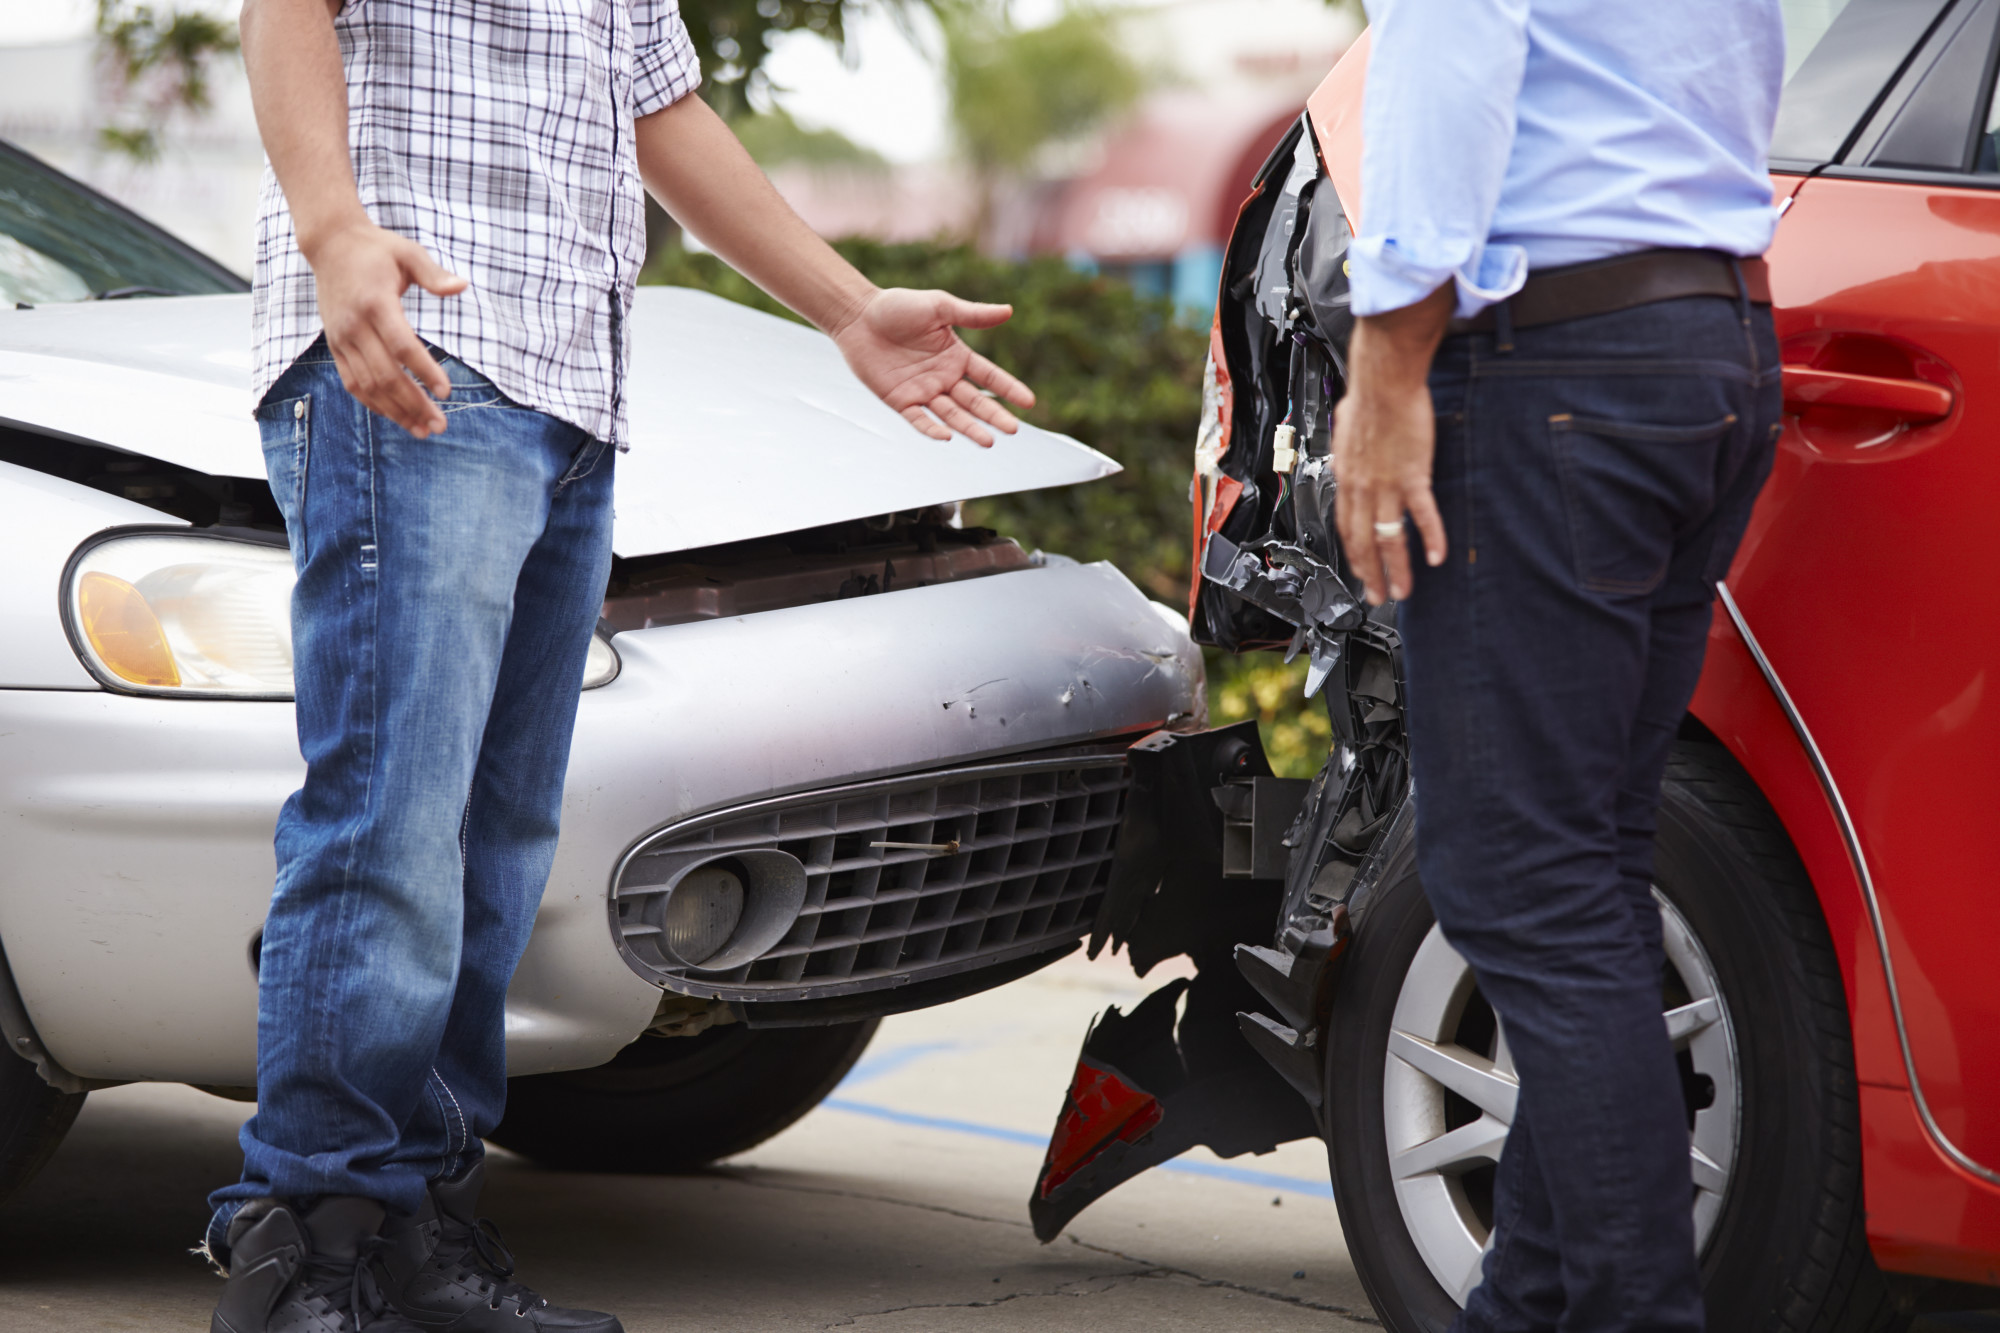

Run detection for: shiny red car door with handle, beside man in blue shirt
[[1728, 0, 2000, 1179]]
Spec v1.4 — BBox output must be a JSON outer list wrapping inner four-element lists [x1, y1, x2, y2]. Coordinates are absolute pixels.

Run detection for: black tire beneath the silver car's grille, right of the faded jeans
[[490, 1019, 878, 1173]]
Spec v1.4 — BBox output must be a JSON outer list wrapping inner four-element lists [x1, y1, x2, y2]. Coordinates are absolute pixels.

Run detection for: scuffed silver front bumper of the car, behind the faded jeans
[[0, 562, 1202, 1085]]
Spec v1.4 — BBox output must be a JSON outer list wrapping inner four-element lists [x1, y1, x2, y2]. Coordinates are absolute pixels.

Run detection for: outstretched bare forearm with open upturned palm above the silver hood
[[638, 96, 1034, 444]]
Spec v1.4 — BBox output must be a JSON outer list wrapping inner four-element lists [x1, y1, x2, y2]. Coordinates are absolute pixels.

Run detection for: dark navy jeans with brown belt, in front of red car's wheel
[[1400, 298, 1782, 1333]]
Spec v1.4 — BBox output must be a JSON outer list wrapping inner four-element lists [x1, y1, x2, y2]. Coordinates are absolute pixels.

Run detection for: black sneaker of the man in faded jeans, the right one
[[376, 1163, 624, 1333]]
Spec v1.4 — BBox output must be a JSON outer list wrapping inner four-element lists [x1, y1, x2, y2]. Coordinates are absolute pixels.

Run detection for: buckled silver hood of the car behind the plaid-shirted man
[[0, 286, 1118, 556]]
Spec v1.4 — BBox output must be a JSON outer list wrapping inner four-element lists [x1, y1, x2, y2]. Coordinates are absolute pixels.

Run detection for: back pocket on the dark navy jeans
[[1548, 412, 1736, 594]]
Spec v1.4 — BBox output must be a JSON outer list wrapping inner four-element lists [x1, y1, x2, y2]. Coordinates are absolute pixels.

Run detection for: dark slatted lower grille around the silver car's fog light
[[612, 753, 1130, 1001]]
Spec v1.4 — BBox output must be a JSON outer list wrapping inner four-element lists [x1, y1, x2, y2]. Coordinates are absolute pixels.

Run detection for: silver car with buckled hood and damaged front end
[[0, 144, 1204, 1193]]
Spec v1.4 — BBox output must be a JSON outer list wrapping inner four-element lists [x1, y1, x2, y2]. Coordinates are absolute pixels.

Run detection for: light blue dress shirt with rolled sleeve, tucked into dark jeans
[[1350, 0, 1784, 316]]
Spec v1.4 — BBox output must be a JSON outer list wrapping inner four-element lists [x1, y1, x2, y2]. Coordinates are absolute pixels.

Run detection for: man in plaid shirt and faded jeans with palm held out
[[206, 0, 1032, 1333]]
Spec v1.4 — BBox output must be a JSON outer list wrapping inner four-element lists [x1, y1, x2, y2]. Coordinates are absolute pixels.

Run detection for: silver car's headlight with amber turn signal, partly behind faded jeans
[[62, 532, 618, 699]]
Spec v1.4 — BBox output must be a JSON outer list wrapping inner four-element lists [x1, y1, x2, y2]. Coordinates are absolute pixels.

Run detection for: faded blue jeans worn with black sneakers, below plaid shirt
[[208, 340, 614, 1255]]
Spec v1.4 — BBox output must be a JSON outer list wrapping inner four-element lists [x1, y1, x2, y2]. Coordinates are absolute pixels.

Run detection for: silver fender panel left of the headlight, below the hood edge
[[0, 456, 176, 691]]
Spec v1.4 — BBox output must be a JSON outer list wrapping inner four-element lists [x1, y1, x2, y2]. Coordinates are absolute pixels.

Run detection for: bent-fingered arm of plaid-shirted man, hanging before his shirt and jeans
[[242, 0, 466, 436]]
